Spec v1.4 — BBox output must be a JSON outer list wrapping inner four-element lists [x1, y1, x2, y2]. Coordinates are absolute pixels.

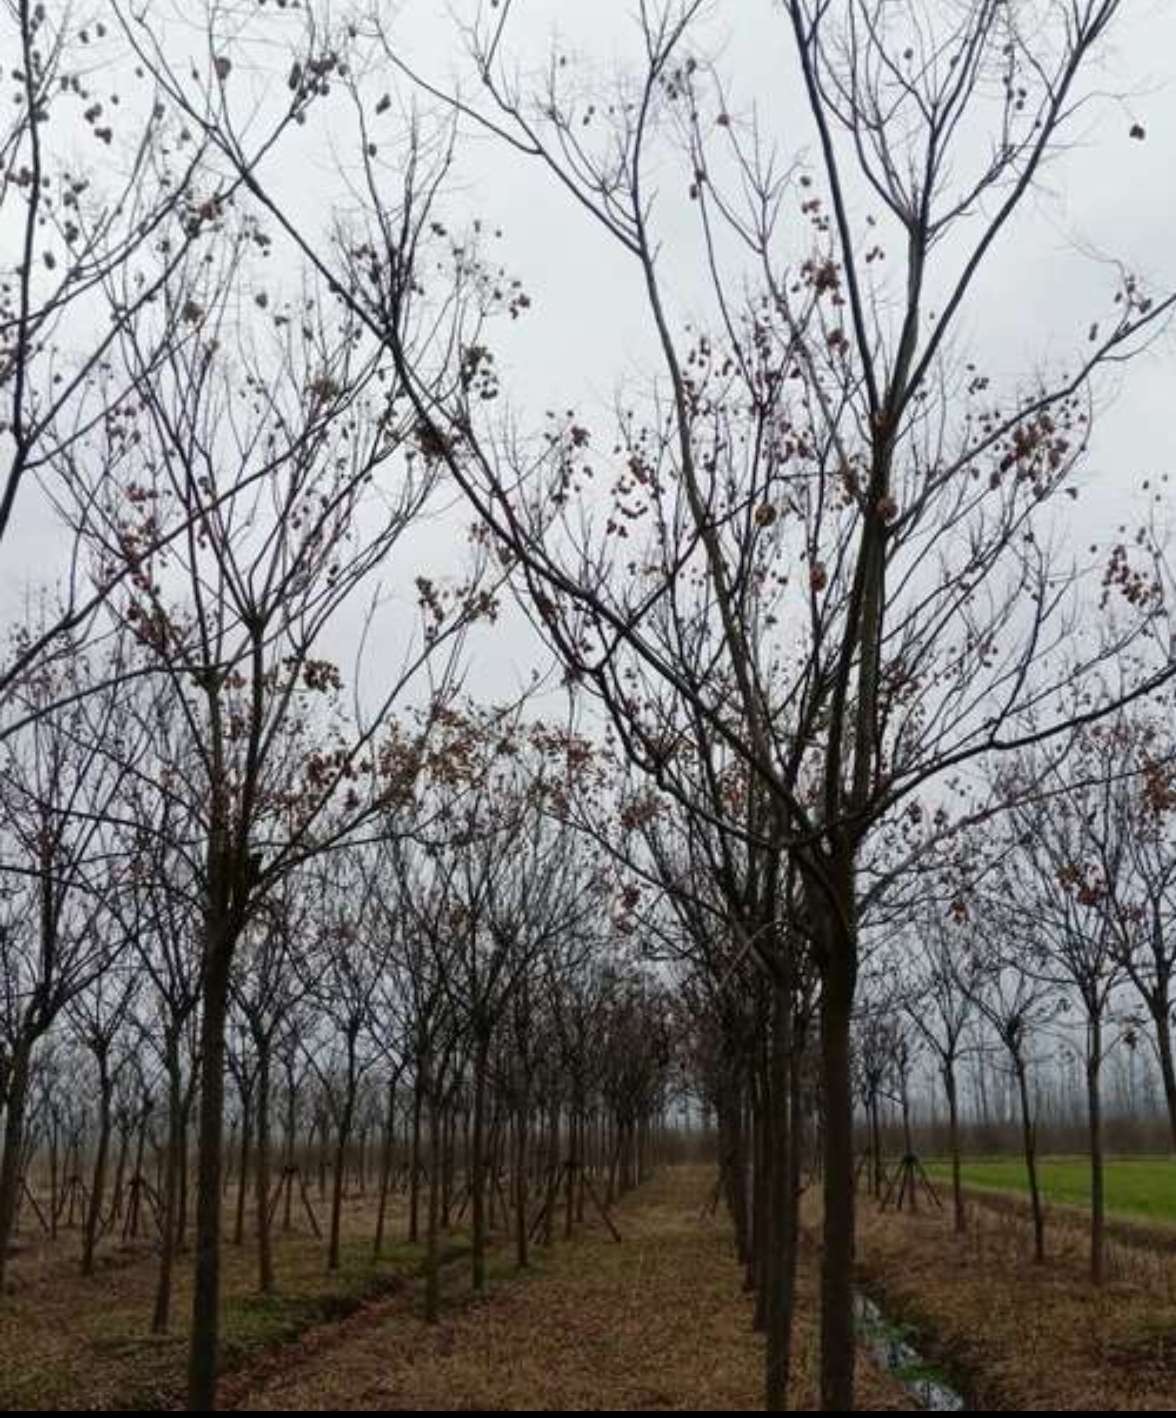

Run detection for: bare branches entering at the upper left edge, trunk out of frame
[[0, 0, 237, 703]]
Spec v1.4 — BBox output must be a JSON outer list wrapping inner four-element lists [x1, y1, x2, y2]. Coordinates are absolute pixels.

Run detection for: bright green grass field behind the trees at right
[[926, 1157, 1176, 1225]]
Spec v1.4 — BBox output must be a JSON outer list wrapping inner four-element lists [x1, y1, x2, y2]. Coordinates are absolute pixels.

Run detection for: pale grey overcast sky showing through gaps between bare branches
[[0, 0, 1176, 720]]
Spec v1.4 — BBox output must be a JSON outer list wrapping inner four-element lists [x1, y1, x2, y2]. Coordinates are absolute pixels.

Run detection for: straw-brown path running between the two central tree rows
[[233, 1168, 911, 1411]]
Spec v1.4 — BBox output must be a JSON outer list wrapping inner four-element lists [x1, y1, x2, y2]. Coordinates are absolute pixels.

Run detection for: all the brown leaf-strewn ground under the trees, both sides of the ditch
[[22, 1167, 1176, 1411]]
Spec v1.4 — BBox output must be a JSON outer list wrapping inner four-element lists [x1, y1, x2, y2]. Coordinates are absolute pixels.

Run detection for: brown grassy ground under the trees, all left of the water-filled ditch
[[0, 1167, 936, 1411]]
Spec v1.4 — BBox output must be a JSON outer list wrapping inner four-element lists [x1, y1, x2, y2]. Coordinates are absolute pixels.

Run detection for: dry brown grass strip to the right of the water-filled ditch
[[858, 1198, 1176, 1411]]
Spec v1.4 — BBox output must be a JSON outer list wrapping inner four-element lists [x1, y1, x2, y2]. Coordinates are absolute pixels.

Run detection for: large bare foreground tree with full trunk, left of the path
[[71, 208, 492, 1407]]
